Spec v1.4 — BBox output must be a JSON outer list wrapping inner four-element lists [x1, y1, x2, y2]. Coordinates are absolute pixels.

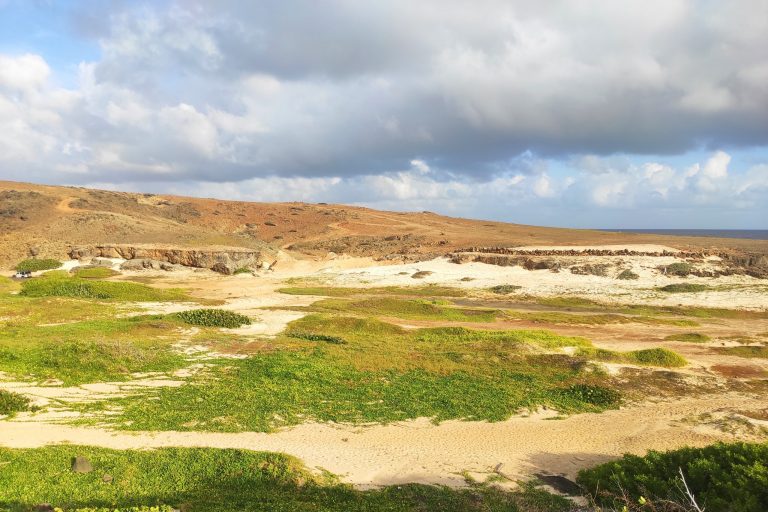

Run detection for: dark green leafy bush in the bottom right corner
[[577, 443, 768, 512]]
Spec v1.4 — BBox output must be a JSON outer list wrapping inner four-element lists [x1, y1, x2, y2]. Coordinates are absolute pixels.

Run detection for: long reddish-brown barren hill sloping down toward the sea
[[0, 181, 768, 268]]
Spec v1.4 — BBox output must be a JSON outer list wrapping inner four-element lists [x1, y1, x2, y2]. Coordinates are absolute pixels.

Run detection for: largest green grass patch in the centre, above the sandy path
[[84, 315, 616, 432]]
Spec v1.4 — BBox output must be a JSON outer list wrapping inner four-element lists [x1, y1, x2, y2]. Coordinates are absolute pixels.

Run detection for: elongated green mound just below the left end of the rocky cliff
[[21, 272, 188, 302]]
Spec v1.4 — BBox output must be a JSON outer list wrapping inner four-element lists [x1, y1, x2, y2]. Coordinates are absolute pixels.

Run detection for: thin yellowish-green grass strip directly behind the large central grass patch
[[311, 297, 500, 322]]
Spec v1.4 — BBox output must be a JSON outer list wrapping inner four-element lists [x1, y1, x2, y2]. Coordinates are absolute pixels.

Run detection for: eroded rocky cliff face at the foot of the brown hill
[[69, 244, 276, 274]]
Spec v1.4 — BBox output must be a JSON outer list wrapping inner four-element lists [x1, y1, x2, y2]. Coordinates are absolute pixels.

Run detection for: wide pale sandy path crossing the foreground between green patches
[[0, 394, 765, 486]]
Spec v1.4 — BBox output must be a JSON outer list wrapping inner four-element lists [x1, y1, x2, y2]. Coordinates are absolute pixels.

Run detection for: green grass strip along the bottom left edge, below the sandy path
[[0, 446, 570, 512]]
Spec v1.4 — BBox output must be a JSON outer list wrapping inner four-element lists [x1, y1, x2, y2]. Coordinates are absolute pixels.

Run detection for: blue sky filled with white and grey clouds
[[0, 0, 768, 229]]
